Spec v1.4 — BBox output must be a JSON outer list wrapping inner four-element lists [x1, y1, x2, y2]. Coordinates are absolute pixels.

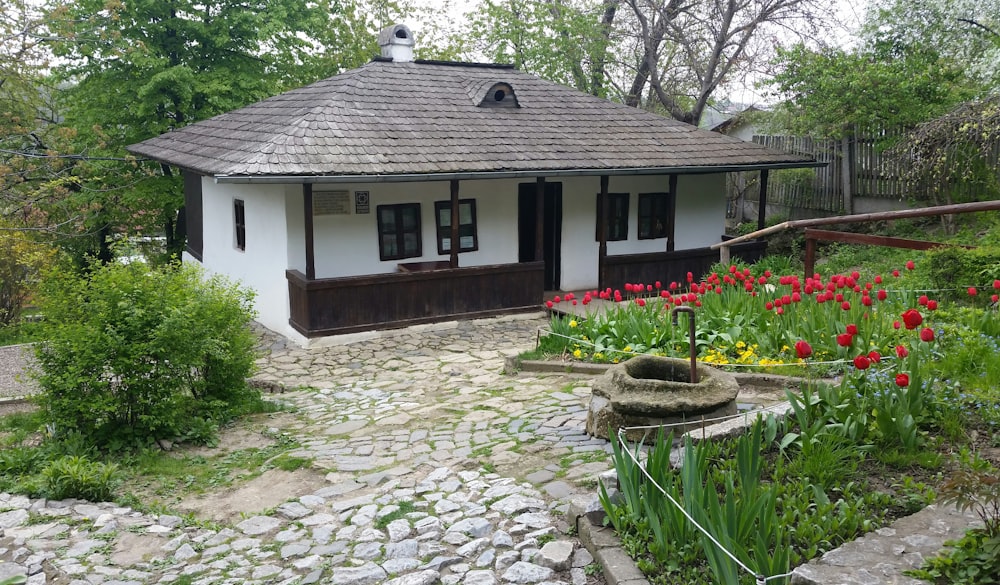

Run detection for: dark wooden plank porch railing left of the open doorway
[[285, 262, 544, 337]]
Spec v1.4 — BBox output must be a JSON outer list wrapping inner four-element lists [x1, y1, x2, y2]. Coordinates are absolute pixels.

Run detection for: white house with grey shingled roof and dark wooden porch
[[129, 25, 816, 343]]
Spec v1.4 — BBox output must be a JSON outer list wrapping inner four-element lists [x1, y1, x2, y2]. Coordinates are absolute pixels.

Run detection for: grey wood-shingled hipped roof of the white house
[[128, 59, 816, 181]]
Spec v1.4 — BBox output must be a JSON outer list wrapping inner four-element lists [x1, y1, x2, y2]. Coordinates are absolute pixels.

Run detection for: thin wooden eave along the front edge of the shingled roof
[[214, 161, 829, 184]]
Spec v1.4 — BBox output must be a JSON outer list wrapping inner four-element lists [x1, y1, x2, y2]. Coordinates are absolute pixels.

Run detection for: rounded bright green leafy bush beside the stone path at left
[[35, 263, 260, 451]]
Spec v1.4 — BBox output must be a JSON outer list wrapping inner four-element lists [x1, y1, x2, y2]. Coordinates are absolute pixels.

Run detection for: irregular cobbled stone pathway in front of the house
[[0, 318, 610, 585]]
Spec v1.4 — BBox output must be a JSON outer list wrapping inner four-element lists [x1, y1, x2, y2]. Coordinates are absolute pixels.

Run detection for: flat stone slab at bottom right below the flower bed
[[792, 504, 982, 585]]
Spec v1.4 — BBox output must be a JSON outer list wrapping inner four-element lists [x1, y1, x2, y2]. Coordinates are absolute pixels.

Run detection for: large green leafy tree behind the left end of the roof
[[48, 0, 374, 256]]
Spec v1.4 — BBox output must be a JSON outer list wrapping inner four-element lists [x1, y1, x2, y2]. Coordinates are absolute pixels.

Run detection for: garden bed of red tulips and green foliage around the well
[[540, 260, 1000, 584]]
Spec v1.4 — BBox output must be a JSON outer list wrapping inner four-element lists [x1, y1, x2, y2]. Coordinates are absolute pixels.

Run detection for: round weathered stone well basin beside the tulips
[[587, 355, 739, 442]]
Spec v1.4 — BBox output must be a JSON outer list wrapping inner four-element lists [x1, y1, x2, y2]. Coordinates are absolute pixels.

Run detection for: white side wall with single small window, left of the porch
[[202, 178, 294, 338]]
